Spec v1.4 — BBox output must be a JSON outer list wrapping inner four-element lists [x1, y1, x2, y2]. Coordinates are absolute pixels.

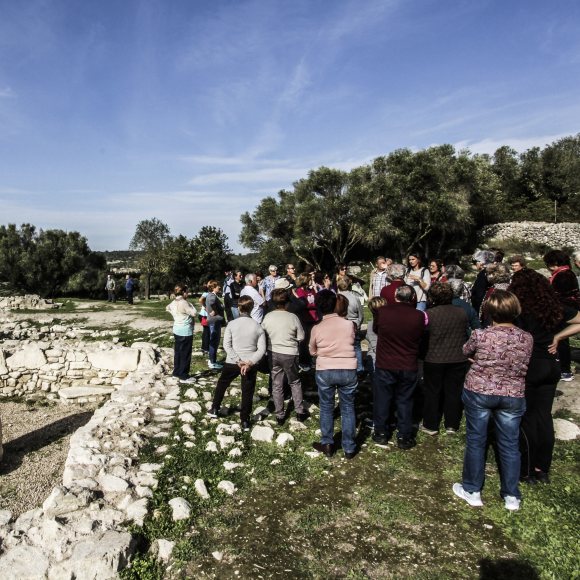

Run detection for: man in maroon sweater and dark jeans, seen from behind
[[373, 286, 425, 449]]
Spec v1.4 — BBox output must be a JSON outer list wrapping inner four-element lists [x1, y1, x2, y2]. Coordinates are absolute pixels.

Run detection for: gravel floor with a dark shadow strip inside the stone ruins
[[0, 401, 96, 516]]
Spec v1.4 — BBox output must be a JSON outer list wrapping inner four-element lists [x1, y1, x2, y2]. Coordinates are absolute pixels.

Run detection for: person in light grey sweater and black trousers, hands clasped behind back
[[207, 296, 266, 431]]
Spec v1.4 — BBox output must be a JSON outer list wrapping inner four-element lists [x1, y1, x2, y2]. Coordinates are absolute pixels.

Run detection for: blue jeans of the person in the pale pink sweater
[[316, 369, 358, 453]]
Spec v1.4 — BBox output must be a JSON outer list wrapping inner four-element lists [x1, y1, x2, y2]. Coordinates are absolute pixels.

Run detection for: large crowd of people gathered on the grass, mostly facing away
[[167, 250, 580, 510]]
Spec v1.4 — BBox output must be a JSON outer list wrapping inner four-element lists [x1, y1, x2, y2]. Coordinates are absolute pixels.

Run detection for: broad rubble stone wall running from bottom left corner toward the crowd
[[0, 368, 180, 580]]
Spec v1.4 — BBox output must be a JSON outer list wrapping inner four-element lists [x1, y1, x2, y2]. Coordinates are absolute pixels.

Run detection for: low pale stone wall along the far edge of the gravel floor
[[0, 339, 170, 403]]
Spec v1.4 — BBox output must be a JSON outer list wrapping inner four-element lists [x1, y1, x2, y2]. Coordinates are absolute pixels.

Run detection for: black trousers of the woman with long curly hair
[[520, 358, 560, 477]]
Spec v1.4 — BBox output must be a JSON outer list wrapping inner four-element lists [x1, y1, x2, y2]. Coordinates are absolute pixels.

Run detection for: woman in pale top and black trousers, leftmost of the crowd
[[165, 284, 197, 383]]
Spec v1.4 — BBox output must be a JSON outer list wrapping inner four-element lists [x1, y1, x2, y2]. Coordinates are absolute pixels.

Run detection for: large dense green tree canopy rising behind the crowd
[[240, 134, 580, 267]]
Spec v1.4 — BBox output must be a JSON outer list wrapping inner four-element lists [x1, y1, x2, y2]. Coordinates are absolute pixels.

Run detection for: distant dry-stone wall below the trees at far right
[[479, 222, 580, 249]]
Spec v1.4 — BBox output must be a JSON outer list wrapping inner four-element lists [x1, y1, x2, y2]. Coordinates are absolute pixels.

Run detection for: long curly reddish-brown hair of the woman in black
[[508, 268, 564, 331]]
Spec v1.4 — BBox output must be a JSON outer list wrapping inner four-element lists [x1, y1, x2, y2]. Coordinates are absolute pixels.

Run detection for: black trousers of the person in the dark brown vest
[[423, 361, 467, 431]]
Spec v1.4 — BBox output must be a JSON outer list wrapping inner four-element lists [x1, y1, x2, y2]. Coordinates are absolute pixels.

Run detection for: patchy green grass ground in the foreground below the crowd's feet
[[123, 358, 580, 579]]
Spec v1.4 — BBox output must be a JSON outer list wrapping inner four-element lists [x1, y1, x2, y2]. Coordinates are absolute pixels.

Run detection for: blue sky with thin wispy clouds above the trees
[[0, 0, 580, 250]]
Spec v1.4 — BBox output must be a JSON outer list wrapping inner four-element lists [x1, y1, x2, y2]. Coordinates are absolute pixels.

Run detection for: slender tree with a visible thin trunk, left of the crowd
[[129, 218, 169, 299]]
